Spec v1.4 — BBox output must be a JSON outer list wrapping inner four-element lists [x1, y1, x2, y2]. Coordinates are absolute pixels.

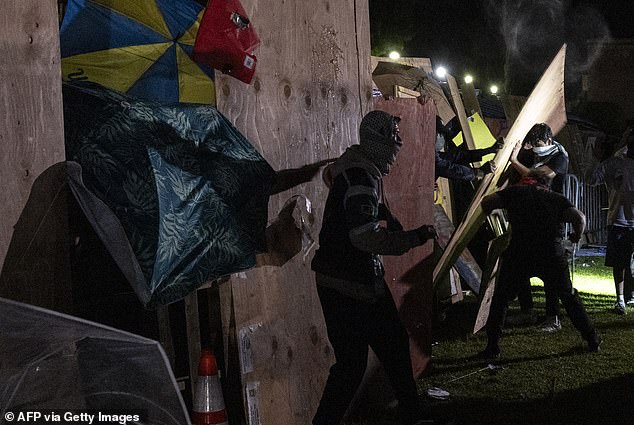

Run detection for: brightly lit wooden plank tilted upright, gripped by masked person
[[434, 45, 566, 282]]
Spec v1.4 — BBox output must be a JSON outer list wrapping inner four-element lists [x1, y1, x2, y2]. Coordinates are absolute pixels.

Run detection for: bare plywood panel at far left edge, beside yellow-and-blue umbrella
[[0, 0, 64, 264]]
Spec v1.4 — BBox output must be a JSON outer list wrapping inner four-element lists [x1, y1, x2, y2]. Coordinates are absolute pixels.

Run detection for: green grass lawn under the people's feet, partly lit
[[346, 257, 634, 425]]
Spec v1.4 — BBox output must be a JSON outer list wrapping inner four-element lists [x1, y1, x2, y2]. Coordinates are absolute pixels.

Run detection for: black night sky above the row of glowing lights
[[370, 0, 634, 95]]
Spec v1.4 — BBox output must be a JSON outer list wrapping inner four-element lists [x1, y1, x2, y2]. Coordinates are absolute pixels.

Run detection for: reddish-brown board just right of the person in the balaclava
[[375, 99, 436, 376]]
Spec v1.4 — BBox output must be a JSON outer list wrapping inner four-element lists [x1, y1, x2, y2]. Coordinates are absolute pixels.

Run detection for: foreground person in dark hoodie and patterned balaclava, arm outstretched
[[311, 111, 435, 425]]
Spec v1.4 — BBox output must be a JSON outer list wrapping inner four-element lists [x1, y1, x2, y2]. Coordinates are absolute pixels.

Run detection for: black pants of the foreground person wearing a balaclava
[[313, 285, 420, 425]]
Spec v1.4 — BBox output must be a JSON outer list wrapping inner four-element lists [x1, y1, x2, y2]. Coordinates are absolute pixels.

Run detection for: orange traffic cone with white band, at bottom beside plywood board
[[192, 350, 228, 425]]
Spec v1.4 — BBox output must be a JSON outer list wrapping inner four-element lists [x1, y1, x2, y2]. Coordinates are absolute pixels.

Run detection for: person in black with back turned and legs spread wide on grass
[[481, 170, 601, 358]]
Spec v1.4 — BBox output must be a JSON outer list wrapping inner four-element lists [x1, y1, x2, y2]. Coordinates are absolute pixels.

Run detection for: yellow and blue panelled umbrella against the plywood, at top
[[60, 0, 215, 104]]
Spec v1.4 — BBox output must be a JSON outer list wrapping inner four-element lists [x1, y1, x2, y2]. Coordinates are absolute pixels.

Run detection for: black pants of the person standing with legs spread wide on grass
[[486, 249, 596, 348]]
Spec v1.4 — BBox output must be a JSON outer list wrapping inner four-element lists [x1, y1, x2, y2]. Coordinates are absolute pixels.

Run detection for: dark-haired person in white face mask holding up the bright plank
[[510, 123, 569, 332]]
